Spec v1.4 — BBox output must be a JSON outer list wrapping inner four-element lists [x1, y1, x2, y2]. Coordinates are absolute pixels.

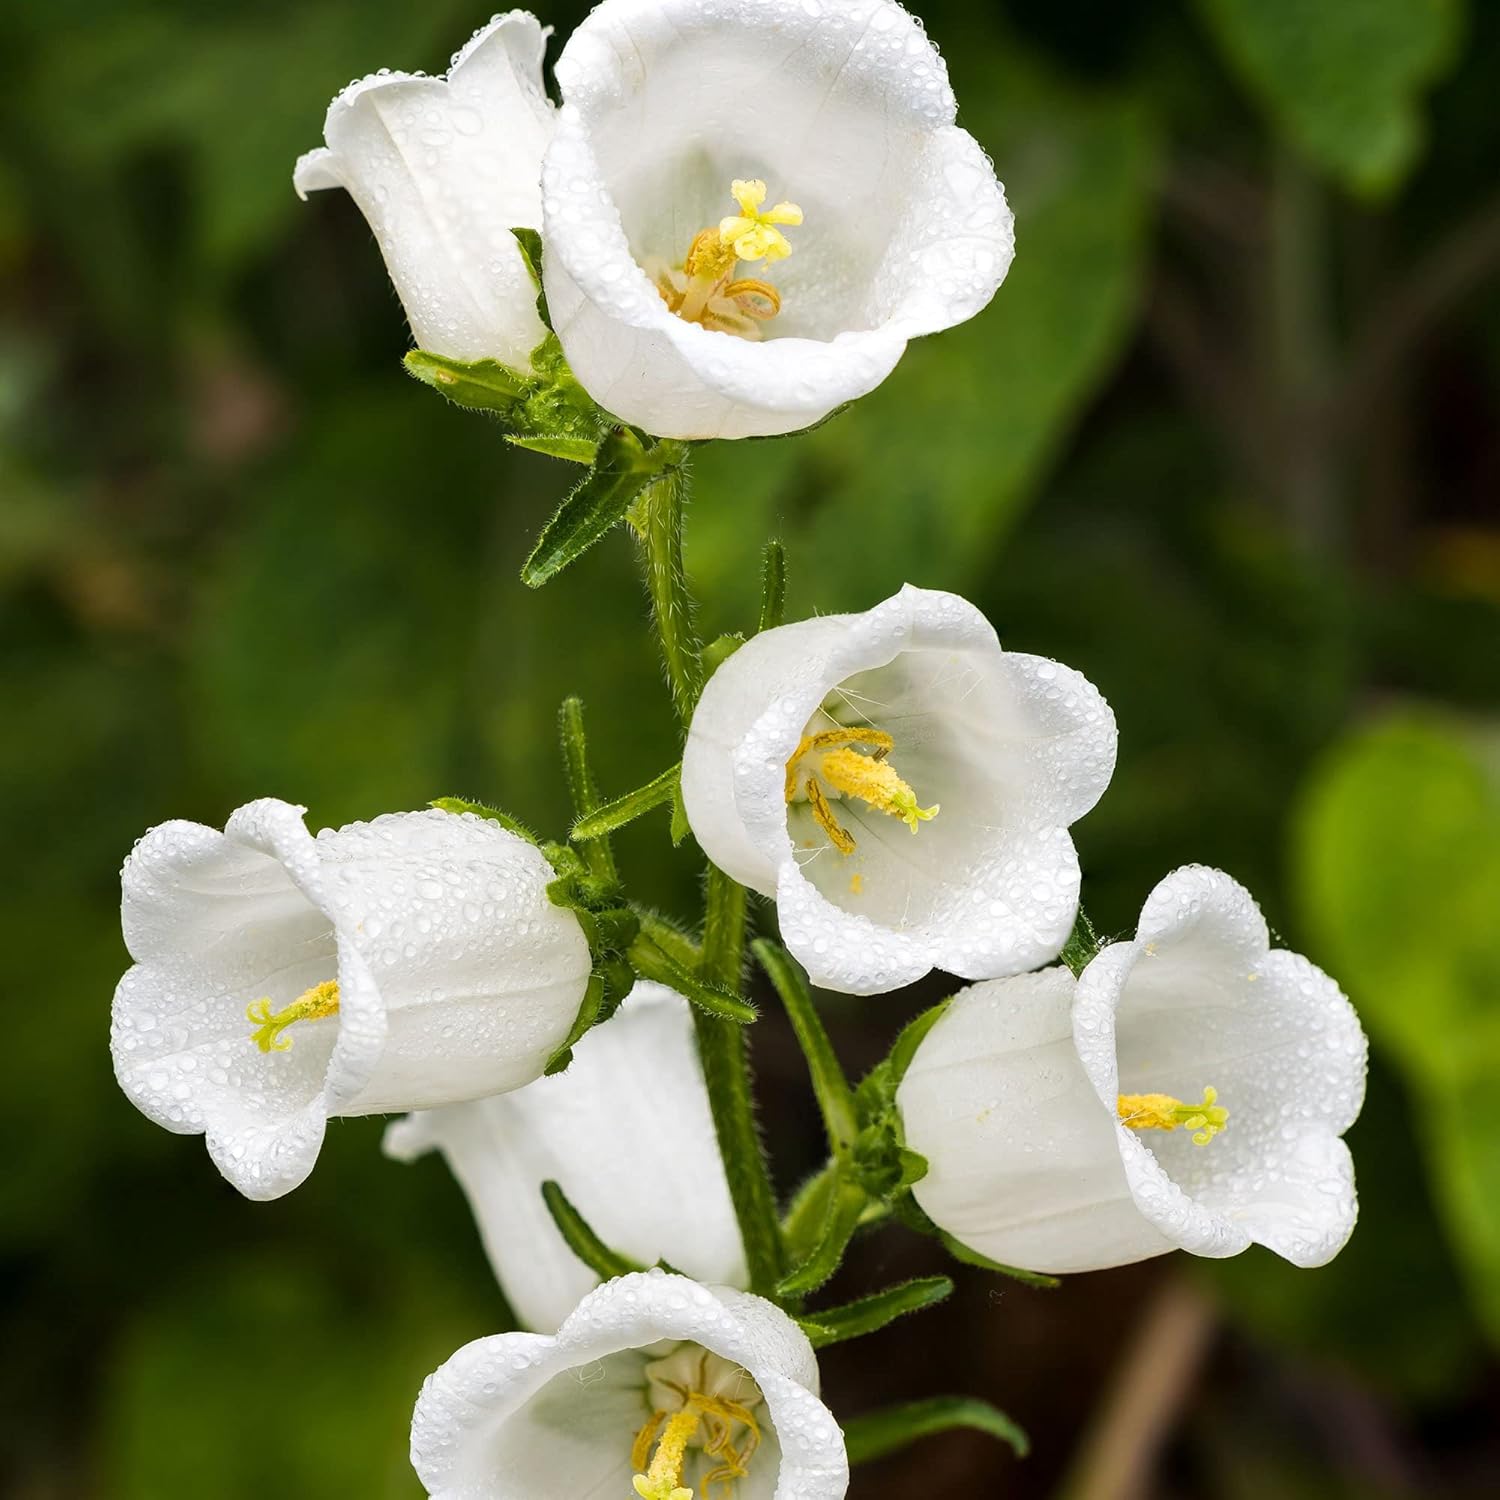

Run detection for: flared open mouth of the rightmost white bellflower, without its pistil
[[1074, 866, 1365, 1265]]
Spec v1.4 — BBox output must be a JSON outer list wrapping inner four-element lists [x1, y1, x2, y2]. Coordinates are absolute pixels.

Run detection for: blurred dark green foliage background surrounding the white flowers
[[0, 0, 1500, 1500]]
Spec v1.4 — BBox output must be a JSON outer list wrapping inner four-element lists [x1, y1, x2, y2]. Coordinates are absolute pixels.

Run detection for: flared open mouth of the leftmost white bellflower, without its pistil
[[111, 798, 384, 1199]]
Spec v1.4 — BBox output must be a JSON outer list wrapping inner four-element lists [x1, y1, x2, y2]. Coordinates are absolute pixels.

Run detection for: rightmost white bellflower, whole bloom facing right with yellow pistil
[[897, 866, 1365, 1272]]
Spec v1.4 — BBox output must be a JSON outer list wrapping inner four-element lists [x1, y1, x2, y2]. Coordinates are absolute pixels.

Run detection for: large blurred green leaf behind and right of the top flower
[[689, 35, 1158, 629]]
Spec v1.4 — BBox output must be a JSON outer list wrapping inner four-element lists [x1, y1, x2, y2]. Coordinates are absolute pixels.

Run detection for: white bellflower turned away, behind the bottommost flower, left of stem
[[386, 981, 747, 1332]]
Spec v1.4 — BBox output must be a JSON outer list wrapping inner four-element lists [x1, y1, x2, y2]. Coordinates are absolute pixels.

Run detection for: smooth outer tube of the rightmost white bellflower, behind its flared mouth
[[897, 968, 1172, 1272]]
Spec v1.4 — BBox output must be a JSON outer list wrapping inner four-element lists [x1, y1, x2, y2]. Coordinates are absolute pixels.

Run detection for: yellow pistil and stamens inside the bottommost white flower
[[630, 1344, 761, 1500]]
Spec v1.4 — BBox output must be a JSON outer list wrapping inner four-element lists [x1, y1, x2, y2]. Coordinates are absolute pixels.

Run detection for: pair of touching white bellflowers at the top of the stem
[[296, 0, 1014, 438]]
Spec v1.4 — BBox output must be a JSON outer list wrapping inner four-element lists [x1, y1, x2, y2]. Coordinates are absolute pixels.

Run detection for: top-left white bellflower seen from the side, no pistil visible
[[293, 11, 554, 369]]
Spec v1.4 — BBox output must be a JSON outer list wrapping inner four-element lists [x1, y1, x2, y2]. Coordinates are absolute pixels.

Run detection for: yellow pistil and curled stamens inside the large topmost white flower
[[656, 177, 803, 339]]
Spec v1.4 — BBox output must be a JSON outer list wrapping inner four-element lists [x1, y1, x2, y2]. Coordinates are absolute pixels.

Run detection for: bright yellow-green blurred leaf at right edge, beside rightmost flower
[[1298, 717, 1500, 1340]]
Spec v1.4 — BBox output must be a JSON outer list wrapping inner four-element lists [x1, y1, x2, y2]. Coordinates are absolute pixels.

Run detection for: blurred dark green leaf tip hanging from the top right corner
[[1199, 0, 1460, 197]]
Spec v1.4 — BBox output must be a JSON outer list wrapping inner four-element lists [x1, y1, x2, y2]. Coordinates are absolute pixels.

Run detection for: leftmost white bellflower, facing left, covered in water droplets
[[111, 798, 591, 1199]]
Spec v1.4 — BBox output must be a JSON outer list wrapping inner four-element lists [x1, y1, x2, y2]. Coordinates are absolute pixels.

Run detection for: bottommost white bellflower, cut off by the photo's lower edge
[[411, 1266, 849, 1500]]
